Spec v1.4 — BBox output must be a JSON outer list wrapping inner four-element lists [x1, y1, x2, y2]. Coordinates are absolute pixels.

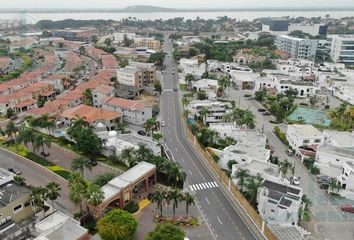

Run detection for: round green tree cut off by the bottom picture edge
[[146, 223, 185, 240]]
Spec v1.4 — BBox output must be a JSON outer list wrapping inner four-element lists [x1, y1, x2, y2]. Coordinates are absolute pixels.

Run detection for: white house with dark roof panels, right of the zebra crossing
[[257, 180, 303, 225]]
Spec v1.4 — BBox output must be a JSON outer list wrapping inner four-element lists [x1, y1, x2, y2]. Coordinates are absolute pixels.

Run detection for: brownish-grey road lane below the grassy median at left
[[0, 148, 75, 212]]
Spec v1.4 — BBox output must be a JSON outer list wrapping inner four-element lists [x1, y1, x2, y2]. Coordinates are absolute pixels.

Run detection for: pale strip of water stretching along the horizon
[[0, 10, 354, 23]]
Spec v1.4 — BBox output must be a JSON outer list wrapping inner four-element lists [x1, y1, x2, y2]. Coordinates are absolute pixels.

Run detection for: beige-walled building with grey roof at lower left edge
[[0, 169, 33, 233]]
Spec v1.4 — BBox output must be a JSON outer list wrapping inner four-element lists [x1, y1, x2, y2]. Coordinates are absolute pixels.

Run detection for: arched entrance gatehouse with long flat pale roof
[[94, 162, 156, 217]]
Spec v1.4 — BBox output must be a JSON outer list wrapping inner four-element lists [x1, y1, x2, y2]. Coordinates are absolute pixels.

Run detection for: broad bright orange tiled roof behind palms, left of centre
[[61, 104, 122, 123]]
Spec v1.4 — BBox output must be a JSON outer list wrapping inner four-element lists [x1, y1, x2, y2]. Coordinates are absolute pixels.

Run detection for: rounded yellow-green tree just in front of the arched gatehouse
[[97, 209, 138, 240]]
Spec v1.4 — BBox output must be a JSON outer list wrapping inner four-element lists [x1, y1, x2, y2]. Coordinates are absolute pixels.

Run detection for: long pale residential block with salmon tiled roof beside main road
[[102, 97, 152, 125]]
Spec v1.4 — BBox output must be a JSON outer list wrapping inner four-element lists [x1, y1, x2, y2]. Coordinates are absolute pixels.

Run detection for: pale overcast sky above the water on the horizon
[[0, 0, 354, 9]]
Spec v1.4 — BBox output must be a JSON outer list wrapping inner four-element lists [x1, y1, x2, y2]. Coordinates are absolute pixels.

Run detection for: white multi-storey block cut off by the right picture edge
[[331, 35, 354, 64]]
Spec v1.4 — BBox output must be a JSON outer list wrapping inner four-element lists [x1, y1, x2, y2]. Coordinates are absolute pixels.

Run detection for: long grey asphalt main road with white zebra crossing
[[161, 37, 257, 240]]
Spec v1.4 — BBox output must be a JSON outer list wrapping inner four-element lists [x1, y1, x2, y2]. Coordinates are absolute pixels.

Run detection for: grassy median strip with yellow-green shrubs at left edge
[[0, 140, 71, 180]]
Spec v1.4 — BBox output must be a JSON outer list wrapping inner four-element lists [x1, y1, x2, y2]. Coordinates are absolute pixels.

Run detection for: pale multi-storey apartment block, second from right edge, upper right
[[275, 35, 318, 60]]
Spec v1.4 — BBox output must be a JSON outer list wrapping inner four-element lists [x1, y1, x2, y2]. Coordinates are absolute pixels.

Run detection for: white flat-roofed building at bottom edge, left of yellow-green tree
[[31, 211, 89, 240]]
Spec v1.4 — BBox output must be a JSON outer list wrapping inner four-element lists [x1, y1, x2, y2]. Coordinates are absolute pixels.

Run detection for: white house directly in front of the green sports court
[[286, 124, 323, 153]]
